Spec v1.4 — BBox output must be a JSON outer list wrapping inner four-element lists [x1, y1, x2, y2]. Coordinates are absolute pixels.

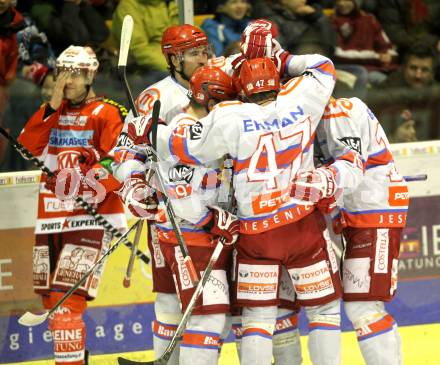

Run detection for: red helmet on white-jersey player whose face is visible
[[161, 24, 208, 62]]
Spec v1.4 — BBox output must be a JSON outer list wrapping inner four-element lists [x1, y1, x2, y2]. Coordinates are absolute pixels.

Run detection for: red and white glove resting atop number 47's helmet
[[240, 19, 278, 59]]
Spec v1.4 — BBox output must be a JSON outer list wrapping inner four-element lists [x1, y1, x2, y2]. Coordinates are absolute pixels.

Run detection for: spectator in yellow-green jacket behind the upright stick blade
[[112, 0, 179, 74]]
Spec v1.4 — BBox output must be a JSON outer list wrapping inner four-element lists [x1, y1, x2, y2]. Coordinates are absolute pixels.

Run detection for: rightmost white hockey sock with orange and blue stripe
[[345, 301, 402, 365]]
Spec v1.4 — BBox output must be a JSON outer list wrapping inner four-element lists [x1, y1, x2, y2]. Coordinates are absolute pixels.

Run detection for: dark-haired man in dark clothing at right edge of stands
[[368, 44, 440, 140]]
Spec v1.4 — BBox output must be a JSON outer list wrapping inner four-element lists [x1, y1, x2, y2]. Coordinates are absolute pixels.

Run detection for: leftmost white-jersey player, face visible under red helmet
[[112, 24, 208, 365]]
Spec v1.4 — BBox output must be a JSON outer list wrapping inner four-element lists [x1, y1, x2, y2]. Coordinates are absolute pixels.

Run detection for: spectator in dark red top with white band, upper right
[[331, 0, 397, 84]]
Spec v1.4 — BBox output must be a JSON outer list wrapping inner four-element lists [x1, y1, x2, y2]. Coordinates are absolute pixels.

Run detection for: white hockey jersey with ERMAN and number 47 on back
[[158, 55, 335, 234]]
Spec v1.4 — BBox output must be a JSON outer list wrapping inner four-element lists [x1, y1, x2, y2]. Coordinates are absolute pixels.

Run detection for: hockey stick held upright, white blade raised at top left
[[118, 15, 198, 285]]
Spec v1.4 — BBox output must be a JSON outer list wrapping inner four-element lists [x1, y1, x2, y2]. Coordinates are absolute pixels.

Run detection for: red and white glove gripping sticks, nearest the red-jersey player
[[119, 174, 159, 218]]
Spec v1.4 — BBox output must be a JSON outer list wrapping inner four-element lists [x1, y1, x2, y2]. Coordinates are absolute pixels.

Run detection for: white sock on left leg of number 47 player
[[240, 306, 277, 365]]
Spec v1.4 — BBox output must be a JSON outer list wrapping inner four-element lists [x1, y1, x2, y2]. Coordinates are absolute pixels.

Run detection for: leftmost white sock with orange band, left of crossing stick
[[152, 293, 182, 365]]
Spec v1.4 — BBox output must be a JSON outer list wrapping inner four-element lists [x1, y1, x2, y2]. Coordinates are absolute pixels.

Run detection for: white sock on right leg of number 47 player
[[305, 300, 341, 365]]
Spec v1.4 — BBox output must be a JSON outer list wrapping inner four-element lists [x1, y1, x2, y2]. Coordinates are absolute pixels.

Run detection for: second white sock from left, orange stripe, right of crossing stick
[[180, 314, 226, 365]]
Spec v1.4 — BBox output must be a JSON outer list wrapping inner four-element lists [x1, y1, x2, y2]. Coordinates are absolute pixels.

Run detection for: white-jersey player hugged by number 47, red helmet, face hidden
[[128, 66, 239, 365]]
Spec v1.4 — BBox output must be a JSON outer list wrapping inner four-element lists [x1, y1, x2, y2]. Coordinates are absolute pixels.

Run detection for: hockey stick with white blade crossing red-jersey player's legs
[[18, 220, 142, 327]]
